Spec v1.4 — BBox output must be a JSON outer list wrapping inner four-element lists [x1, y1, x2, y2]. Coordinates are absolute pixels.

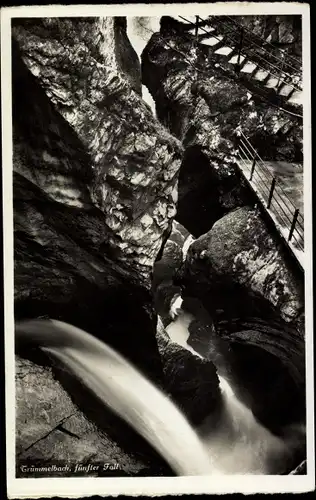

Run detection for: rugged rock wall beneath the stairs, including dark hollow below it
[[142, 18, 302, 236]]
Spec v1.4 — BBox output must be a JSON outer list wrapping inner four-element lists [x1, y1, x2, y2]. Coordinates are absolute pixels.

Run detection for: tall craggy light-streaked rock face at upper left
[[13, 18, 181, 279]]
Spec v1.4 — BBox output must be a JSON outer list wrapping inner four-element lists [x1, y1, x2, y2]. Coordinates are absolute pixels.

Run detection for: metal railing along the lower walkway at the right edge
[[237, 132, 304, 251]]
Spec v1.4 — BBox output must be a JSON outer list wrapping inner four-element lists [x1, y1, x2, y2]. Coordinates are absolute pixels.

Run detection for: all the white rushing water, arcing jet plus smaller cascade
[[15, 313, 304, 476]]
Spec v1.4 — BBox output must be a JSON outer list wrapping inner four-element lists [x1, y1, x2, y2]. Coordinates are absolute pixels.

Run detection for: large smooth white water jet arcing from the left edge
[[15, 320, 216, 476]]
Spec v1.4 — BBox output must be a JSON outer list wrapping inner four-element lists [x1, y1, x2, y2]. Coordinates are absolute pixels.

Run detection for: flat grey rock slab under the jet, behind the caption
[[16, 357, 144, 478]]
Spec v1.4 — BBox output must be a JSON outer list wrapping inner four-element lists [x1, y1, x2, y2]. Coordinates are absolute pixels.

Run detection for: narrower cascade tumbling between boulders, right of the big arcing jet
[[166, 301, 303, 475]]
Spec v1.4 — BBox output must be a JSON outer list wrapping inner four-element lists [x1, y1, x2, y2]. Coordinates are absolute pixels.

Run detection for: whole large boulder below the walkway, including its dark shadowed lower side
[[176, 207, 305, 433]]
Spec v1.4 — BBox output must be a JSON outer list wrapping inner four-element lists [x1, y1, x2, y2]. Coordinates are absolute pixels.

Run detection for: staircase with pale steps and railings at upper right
[[169, 16, 303, 116]]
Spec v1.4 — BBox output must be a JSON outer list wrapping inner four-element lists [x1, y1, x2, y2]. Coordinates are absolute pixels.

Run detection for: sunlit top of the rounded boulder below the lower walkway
[[186, 207, 304, 324]]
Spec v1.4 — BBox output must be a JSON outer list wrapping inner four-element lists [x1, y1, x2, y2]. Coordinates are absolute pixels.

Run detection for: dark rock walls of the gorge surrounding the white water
[[12, 17, 305, 475]]
